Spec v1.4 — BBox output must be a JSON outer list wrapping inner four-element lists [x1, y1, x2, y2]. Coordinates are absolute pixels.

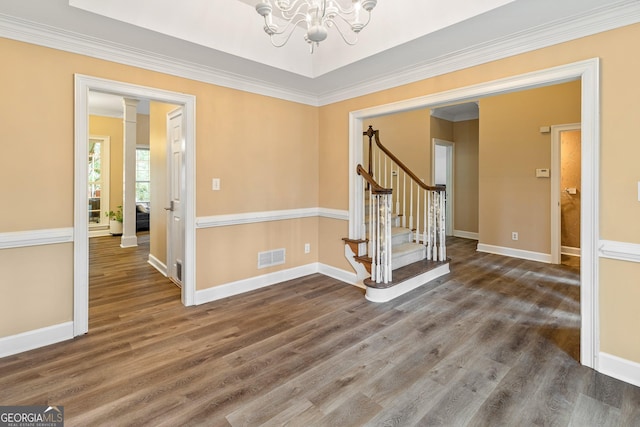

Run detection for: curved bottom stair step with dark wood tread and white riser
[[363, 259, 450, 302]]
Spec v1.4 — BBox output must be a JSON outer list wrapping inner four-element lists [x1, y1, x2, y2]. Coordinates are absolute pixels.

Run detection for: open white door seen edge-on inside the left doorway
[[165, 108, 185, 287]]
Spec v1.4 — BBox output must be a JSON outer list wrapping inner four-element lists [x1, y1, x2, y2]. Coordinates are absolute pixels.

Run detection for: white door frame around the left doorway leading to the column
[[73, 74, 196, 336]]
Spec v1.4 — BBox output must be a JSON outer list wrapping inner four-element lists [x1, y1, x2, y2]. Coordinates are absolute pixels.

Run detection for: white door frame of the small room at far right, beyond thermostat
[[551, 123, 580, 264]]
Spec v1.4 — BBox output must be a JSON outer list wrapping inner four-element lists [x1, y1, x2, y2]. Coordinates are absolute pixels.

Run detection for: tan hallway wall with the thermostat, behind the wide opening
[[479, 81, 581, 254]]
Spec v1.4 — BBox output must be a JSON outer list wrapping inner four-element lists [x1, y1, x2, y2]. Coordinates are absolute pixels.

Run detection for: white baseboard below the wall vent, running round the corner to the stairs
[[195, 263, 355, 305]]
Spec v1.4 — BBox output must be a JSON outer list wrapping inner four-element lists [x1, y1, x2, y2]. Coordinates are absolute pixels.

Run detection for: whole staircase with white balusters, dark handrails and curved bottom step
[[342, 126, 449, 302]]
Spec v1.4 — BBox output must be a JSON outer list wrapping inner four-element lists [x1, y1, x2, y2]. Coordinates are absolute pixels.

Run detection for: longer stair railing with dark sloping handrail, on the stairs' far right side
[[363, 126, 447, 261]]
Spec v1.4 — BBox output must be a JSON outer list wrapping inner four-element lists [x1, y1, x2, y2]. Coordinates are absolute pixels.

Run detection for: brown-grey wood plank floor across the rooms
[[0, 237, 640, 426]]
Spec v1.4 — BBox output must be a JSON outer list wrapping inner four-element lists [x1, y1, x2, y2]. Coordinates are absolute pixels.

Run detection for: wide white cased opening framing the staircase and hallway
[[349, 58, 600, 370]]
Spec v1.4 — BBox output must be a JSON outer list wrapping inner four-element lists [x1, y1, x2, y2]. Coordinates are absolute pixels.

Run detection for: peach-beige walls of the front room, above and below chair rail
[[0, 21, 640, 363]]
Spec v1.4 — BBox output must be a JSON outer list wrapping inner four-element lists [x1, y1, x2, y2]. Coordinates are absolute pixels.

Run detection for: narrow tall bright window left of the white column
[[87, 136, 109, 226]]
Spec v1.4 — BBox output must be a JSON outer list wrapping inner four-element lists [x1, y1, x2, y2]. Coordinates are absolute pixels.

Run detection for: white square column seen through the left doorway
[[120, 98, 139, 248]]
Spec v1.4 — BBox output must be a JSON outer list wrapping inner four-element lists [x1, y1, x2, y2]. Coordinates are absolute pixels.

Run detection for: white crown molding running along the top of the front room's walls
[[0, 0, 640, 106]]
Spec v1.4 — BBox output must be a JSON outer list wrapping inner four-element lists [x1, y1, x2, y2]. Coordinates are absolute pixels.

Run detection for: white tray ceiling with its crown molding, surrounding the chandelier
[[0, 0, 640, 105]]
